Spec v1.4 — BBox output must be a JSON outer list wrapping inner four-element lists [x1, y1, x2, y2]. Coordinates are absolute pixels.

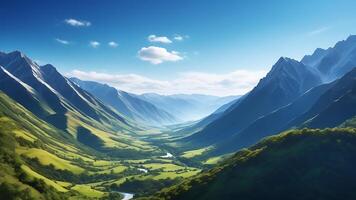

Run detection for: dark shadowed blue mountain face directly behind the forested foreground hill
[[215, 69, 356, 153]]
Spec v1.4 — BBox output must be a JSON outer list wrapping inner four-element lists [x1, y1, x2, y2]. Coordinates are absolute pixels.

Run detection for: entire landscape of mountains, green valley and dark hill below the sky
[[0, 36, 356, 200]]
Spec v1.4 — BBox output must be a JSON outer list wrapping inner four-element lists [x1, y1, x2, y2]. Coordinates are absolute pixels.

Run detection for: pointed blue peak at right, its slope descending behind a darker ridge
[[183, 57, 321, 145]]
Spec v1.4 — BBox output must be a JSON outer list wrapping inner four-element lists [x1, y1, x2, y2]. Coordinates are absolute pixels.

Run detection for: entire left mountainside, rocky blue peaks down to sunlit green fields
[[0, 51, 200, 199]]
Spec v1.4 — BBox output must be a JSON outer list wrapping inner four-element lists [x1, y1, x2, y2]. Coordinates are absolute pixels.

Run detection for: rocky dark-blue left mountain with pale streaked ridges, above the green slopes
[[0, 51, 149, 153]]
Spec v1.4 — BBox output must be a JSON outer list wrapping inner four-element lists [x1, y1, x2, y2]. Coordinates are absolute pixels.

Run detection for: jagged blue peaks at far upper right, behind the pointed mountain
[[301, 35, 356, 82]]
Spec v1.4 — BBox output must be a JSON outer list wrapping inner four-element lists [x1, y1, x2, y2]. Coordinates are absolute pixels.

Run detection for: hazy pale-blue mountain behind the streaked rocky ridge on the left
[[70, 78, 179, 125]]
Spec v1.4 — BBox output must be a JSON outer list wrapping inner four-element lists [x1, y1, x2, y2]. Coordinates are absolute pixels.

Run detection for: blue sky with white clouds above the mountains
[[0, 0, 356, 96]]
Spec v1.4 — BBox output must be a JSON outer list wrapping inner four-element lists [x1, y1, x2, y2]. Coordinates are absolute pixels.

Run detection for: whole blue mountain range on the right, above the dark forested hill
[[181, 36, 356, 154]]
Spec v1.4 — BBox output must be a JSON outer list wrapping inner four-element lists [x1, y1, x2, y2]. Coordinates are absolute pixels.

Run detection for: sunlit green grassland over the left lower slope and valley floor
[[0, 92, 209, 200]]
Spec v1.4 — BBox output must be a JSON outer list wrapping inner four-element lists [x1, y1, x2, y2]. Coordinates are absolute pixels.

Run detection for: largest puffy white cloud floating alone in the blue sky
[[138, 46, 183, 64]]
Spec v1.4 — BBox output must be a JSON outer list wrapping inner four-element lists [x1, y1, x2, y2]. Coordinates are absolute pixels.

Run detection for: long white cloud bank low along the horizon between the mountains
[[67, 70, 266, 96]]
